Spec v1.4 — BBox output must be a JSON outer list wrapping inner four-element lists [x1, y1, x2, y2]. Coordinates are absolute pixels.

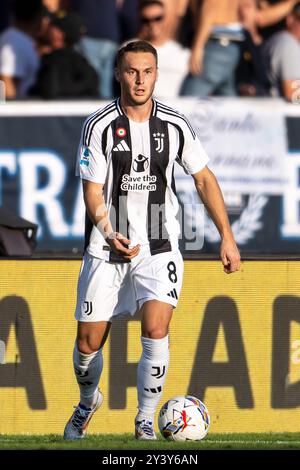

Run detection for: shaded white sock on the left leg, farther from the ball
[[73, 343, 103, 408]]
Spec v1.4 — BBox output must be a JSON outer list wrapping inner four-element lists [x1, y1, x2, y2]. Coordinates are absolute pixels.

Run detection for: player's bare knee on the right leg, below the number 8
[[140, 300, 174, 339]]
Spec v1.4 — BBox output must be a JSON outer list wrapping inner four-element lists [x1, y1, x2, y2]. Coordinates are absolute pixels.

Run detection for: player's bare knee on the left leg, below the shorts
[[77, 321, 111, 354]]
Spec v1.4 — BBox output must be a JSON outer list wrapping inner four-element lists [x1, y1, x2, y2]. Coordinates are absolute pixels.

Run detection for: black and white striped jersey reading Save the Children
[[76, 99, 208, 261]]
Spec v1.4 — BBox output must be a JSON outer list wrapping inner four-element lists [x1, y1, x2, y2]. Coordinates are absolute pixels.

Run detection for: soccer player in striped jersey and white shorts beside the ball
[[64, 41, 240, 440]]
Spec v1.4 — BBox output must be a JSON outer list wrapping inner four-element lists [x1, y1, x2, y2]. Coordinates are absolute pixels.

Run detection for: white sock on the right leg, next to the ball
[[137, 335, 169, 421]]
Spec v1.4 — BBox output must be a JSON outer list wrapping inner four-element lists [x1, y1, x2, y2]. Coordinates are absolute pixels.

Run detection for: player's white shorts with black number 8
[[75, 250, 183, 322]]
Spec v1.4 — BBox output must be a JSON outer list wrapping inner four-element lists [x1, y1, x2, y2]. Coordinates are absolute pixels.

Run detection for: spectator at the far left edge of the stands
[[0, 0, 42, 99]]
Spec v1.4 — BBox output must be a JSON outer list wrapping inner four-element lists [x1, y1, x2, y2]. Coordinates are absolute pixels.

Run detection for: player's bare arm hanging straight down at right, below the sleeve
[[193, 167, 240, 274]]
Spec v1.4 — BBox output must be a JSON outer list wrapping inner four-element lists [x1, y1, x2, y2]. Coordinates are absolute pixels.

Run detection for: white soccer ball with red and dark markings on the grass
[[158, 395, 210, 441]]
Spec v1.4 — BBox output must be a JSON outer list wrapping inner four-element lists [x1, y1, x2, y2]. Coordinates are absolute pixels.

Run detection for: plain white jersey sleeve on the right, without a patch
[[177, 122, 209, 175]]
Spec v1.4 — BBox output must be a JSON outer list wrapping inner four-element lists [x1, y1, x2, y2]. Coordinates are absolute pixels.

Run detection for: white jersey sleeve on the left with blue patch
[[76, 123, 107, 184]]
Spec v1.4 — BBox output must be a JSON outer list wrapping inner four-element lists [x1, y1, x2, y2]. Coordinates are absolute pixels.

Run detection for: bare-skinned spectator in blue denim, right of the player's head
[[181, 0, 244, 97]]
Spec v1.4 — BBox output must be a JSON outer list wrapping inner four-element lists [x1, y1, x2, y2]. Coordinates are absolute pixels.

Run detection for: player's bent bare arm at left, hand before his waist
[[82, 180, 140, 260]]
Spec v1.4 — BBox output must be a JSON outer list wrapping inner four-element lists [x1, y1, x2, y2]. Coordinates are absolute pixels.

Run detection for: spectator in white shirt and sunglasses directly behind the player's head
[[128, 0, 190, 99]]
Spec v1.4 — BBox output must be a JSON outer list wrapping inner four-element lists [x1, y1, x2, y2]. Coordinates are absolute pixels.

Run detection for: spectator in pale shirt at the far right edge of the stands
[[264, 2, 300, 101]]
